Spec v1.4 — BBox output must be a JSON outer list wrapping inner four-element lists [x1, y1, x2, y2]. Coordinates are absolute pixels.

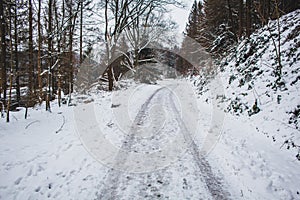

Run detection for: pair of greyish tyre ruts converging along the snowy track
[[97, 83, 230, 199]]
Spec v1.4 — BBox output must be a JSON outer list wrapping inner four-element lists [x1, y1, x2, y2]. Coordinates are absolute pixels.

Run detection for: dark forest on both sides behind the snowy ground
[[0, 0, 299, 121]]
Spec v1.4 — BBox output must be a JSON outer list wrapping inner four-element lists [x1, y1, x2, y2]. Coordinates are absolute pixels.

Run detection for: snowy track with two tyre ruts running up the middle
[[94, 84, 230, 199]]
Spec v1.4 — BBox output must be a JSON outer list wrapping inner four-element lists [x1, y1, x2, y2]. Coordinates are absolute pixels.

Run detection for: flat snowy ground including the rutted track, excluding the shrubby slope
[[0, 77, 300, 199]]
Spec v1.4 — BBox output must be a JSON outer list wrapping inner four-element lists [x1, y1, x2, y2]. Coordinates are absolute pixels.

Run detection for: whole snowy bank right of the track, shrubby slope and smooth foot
[[193, 10, 300, 199]]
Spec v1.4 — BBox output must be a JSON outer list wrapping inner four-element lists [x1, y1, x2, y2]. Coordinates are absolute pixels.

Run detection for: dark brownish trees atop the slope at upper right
[[179, 0, 300, 60]]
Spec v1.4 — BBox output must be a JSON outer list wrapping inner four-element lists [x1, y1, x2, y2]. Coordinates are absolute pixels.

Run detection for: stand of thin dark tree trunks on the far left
[[0, 0, 91, 121]]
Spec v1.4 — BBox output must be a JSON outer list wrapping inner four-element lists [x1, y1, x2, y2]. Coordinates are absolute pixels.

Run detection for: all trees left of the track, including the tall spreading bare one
[[0, 0, 182, 121]]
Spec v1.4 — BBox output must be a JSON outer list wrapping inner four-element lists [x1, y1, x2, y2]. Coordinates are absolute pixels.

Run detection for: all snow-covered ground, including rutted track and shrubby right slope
[[0, 10, 300, 200]]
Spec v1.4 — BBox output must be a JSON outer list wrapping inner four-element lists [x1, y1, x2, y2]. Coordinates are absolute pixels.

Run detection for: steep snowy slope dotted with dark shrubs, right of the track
[[194, 10, 300, 160]]
